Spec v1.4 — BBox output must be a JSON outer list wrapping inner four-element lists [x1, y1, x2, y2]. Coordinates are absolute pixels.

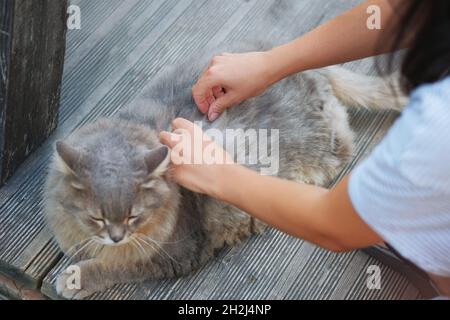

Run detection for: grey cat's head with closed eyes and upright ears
[[55, 142, 178, 246]]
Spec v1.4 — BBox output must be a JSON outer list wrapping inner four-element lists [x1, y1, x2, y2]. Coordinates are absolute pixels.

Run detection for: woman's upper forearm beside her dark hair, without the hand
[[269, 0, 406, 82]]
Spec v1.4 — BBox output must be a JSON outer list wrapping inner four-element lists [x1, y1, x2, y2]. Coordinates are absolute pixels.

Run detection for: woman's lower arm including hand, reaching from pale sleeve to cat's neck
[[161, 119, 382, 251]]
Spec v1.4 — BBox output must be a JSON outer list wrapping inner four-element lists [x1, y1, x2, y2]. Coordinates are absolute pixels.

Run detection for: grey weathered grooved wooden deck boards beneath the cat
[[0, 0, 419, 299]]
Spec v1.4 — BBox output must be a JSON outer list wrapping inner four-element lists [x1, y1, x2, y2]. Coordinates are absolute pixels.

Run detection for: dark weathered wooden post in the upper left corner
[[0, 0, 67, 185]]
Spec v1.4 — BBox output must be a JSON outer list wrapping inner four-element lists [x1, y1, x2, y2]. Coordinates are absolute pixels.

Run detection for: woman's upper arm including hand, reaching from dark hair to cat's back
[[192, 0, 406, 121]]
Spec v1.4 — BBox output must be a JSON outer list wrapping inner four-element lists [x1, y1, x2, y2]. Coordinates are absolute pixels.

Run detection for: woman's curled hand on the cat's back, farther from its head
[[192, 52, 277, 121]]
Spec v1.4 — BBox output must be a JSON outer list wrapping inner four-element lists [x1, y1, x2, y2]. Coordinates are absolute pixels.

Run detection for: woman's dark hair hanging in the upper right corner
[[391, 0, 450, 93]]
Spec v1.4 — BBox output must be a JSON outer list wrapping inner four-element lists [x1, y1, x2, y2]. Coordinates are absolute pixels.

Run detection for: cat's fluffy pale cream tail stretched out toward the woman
[[324, 67, 408, 111]]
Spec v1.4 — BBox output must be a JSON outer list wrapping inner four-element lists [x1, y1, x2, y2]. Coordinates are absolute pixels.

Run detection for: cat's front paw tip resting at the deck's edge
[[56, 267, 96, 300]]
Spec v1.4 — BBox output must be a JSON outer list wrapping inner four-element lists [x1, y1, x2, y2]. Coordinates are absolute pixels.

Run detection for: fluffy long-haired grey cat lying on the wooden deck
[[45, 41, 404, 299]]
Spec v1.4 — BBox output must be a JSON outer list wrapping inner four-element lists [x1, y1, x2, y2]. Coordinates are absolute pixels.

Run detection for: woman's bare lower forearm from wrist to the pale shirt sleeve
[[212, 166, 381, 251]]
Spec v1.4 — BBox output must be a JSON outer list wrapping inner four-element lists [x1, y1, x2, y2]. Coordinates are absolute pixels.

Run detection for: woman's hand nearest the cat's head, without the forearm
[[160, 118, 237, 198]]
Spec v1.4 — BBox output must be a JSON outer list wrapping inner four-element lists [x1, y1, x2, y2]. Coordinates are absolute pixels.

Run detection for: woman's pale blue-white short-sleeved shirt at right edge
[[349, 78, 450, 277]]
